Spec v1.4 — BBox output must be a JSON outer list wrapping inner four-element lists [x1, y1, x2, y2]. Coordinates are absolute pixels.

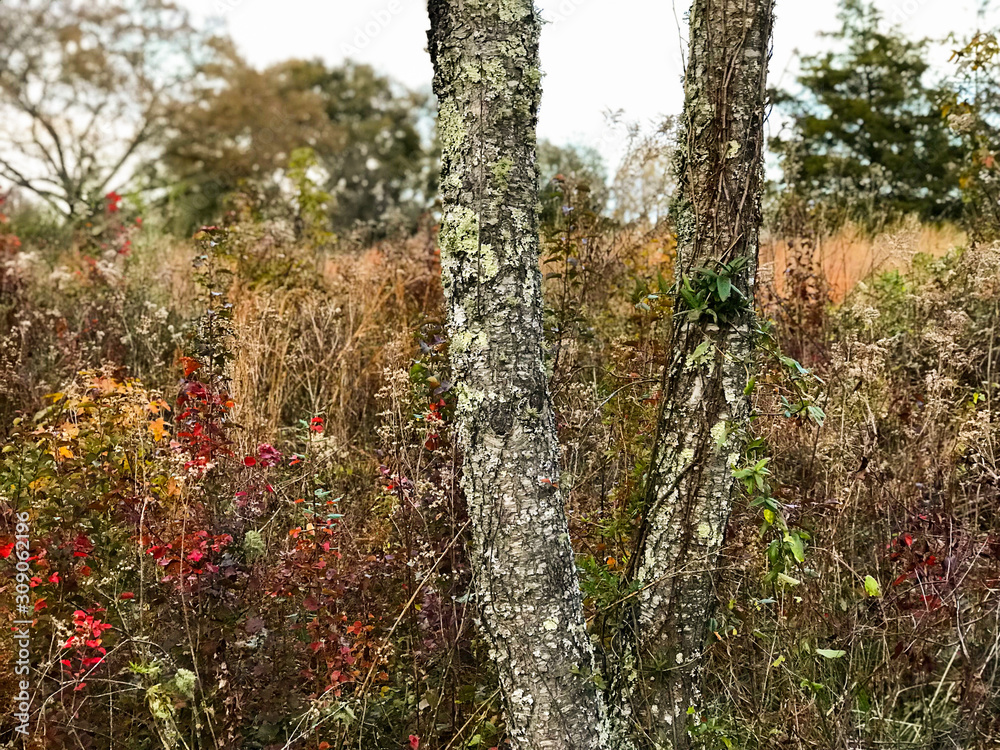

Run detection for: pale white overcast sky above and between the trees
[[179, 0, 988, 170]]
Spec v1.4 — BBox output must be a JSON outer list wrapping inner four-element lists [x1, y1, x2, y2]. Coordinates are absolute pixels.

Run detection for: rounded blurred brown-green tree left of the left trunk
[[164, 55, 433, 235]]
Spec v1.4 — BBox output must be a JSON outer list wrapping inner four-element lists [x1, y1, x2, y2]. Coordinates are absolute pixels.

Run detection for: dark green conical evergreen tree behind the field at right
[[771, 0, 961, 229]]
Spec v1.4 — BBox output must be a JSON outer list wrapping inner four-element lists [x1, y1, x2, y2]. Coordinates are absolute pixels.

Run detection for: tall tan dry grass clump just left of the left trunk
[[231, 229, 440, 446]]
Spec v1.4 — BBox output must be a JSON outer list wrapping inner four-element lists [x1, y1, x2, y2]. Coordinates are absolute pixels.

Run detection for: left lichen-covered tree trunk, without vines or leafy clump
[[428, 0, 605, 750]]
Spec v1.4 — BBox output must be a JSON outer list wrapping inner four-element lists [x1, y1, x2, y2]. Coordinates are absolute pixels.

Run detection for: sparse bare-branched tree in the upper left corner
[[0, 0, 217, 217]]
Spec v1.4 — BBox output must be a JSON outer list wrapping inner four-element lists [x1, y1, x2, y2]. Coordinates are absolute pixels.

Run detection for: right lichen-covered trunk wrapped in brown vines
[[617, 0, 774, 749]]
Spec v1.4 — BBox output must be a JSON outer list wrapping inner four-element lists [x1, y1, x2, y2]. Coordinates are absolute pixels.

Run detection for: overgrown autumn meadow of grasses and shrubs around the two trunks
[[7, 148, 1000, 750]]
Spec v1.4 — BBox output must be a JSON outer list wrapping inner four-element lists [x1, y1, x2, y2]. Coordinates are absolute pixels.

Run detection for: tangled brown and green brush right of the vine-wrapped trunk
[[706, 245, 1000, 748]]
